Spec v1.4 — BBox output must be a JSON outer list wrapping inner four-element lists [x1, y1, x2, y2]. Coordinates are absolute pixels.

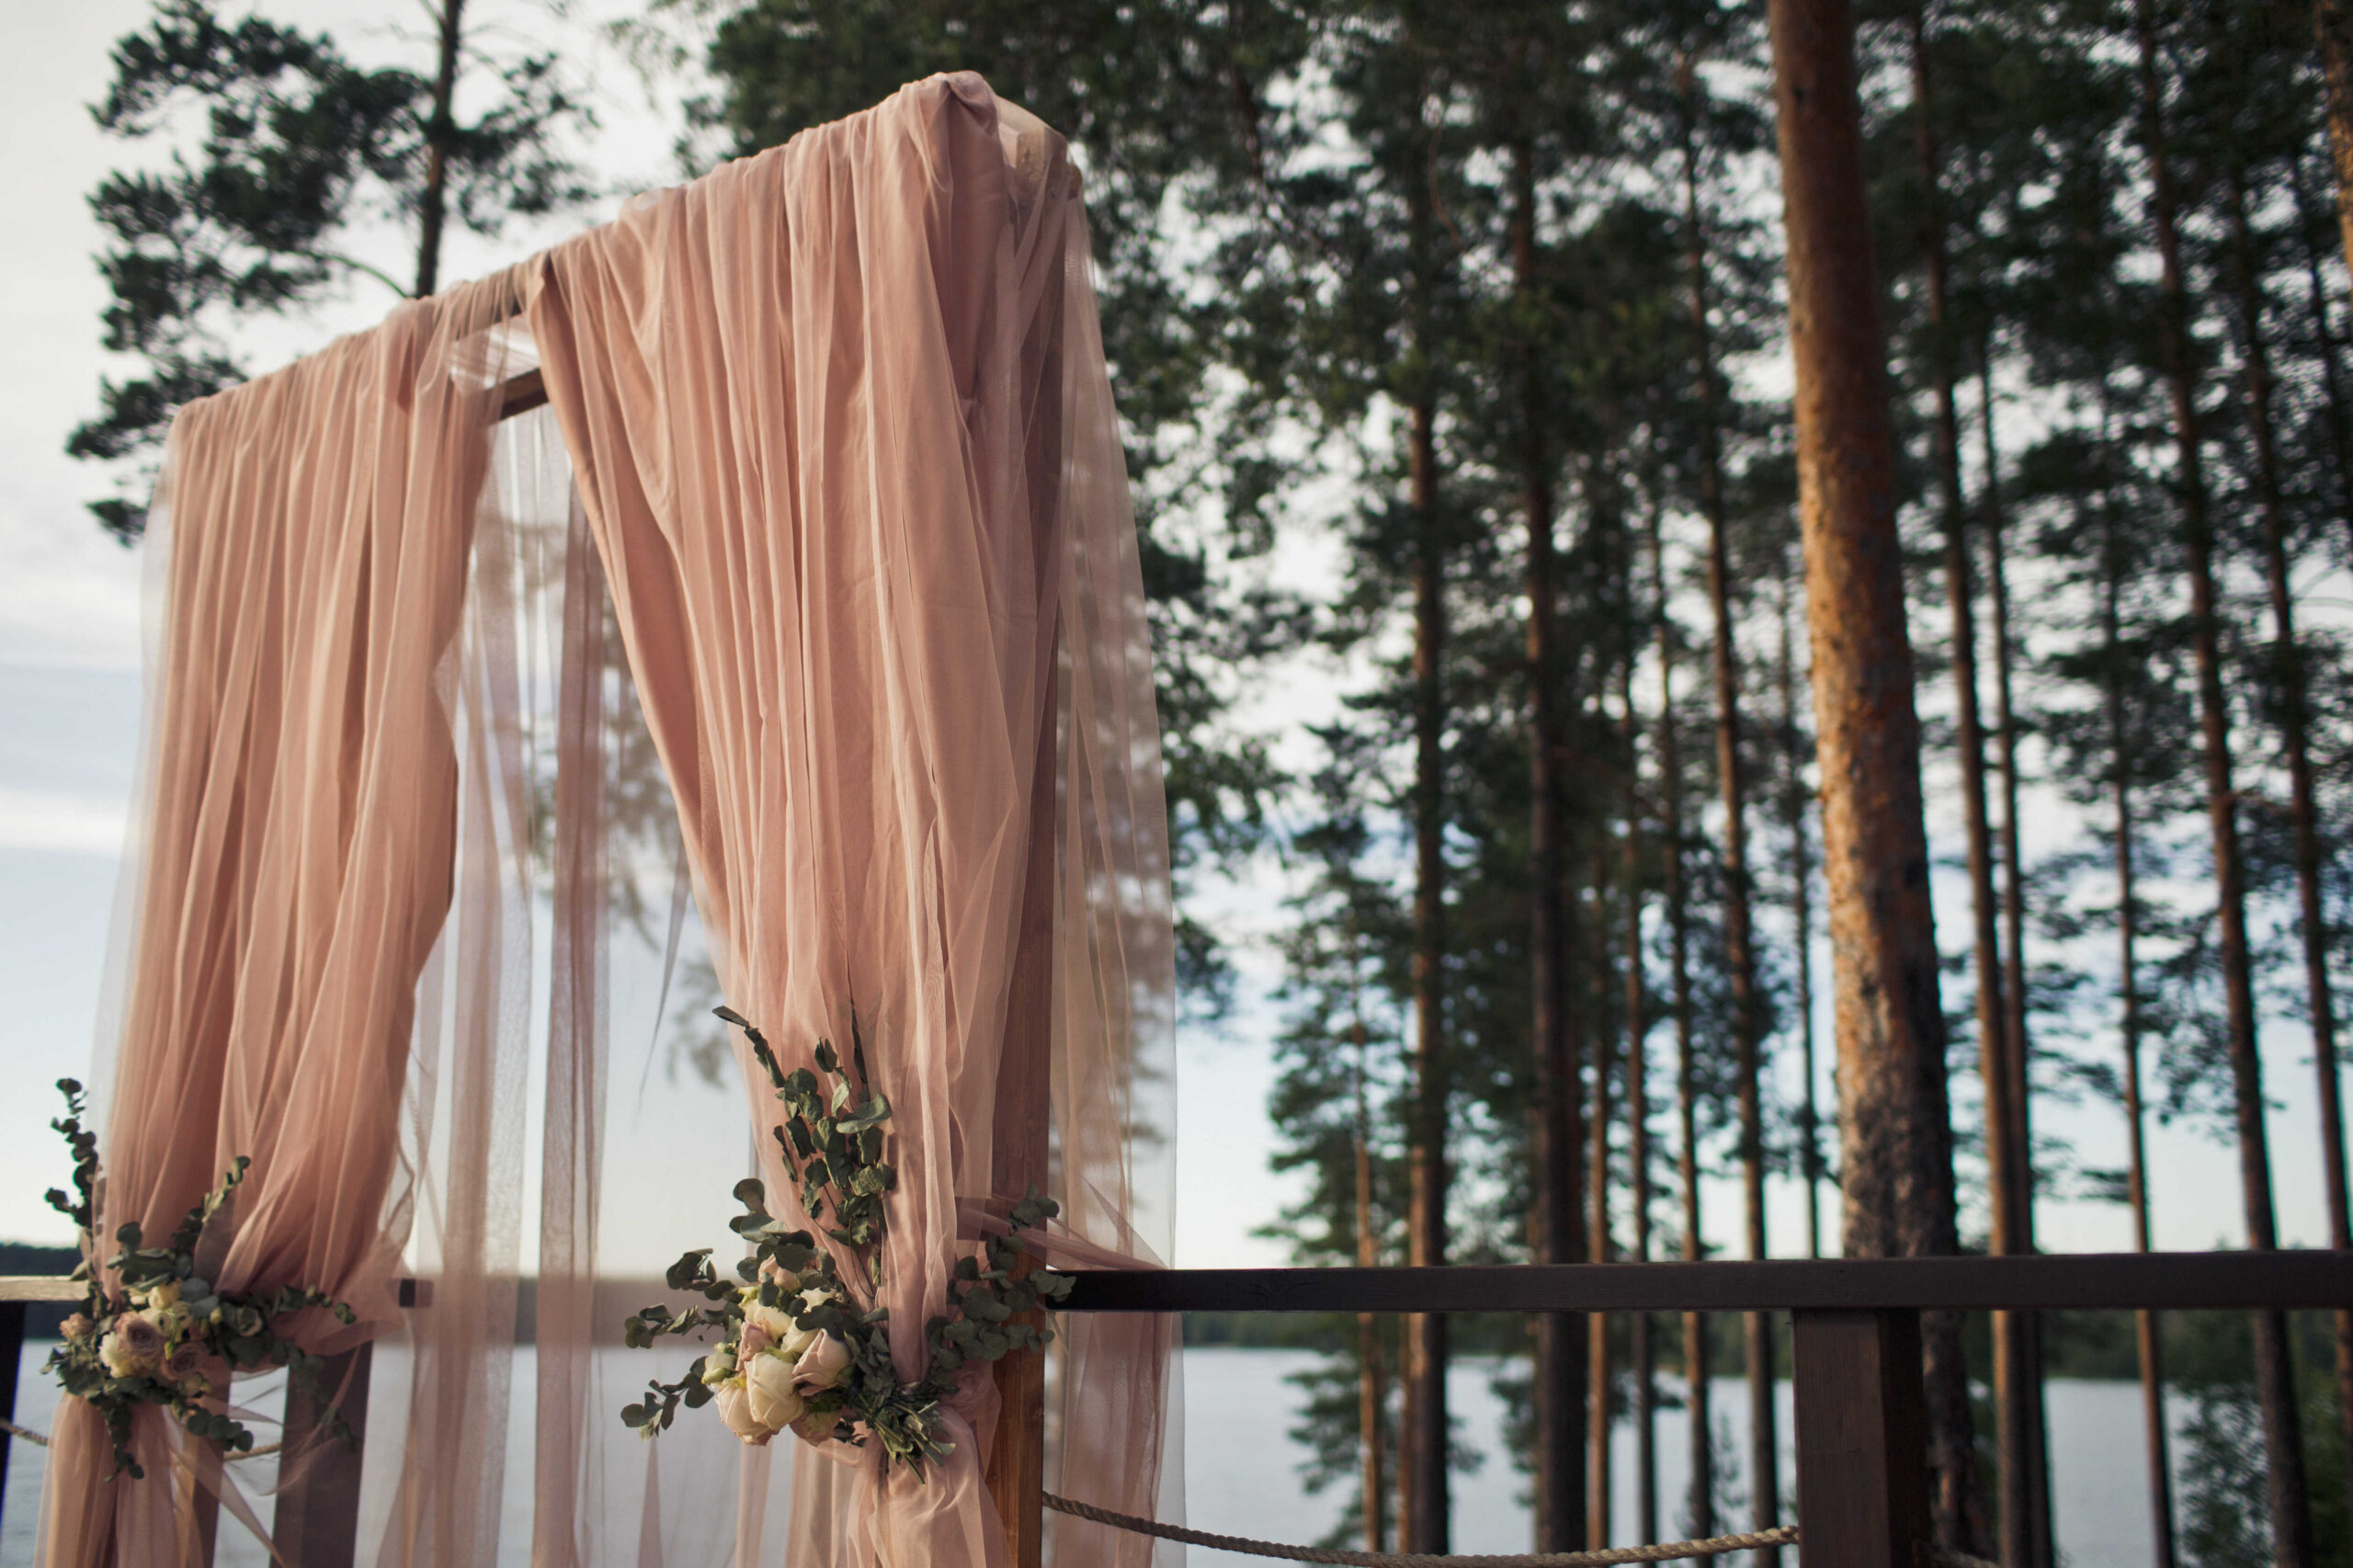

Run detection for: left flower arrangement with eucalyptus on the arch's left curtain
[[47, 1078, 353, 1479]]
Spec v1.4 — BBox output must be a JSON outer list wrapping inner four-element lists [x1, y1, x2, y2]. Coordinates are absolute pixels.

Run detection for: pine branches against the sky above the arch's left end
[[66, 0, 588, 541]]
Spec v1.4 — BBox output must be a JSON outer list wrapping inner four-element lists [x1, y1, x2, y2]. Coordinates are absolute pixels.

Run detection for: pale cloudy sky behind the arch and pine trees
[[0, 0, 2325, 1271]]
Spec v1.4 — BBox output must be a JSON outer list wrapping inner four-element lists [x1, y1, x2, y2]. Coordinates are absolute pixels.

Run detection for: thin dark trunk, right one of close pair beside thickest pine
[[1976, 341, 2056, 1568]]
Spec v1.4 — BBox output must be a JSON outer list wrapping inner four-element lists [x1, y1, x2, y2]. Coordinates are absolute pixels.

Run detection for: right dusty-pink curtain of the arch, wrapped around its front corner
[[529, 73, 1176, 1568]]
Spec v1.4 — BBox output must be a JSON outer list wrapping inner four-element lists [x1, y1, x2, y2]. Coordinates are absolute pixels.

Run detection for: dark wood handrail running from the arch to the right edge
[[1063, 1250, 2353, 1312]]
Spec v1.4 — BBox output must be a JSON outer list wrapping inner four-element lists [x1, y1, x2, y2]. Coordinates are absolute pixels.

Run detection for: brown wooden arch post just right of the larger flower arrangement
[[988, 654, 1059, 1568]]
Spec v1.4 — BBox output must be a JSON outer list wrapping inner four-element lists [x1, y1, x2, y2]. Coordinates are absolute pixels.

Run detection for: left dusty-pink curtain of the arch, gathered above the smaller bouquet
[[42, 273, 555, 1568]]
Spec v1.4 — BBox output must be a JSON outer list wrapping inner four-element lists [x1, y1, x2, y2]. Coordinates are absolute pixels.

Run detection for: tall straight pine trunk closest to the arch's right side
[[1403, 143, 1452, 1551]]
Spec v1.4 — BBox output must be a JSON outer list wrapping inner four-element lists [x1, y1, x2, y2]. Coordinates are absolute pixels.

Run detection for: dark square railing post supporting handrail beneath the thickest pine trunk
[[1793, 1309, 1929, 1568]]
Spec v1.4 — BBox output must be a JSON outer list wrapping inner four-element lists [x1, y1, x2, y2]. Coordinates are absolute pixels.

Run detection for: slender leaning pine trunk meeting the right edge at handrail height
[[2231, 158, 2353, 1525]]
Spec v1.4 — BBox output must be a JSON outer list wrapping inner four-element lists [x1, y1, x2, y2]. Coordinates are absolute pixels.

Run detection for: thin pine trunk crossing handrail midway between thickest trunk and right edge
[[2101, 400, 2177, 1568]]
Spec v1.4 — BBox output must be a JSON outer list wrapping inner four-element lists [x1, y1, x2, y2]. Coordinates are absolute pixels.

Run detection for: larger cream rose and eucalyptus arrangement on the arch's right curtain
[[621, 1007, 1071, 1474]]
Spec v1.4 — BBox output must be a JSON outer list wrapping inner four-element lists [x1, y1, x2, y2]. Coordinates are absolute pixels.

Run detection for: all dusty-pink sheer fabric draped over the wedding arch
[[42, 63, 1181, 1568]]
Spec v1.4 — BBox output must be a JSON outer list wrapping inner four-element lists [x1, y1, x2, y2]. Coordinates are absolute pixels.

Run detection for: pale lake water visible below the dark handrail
[[0, 1345, 2151, 1568]]
